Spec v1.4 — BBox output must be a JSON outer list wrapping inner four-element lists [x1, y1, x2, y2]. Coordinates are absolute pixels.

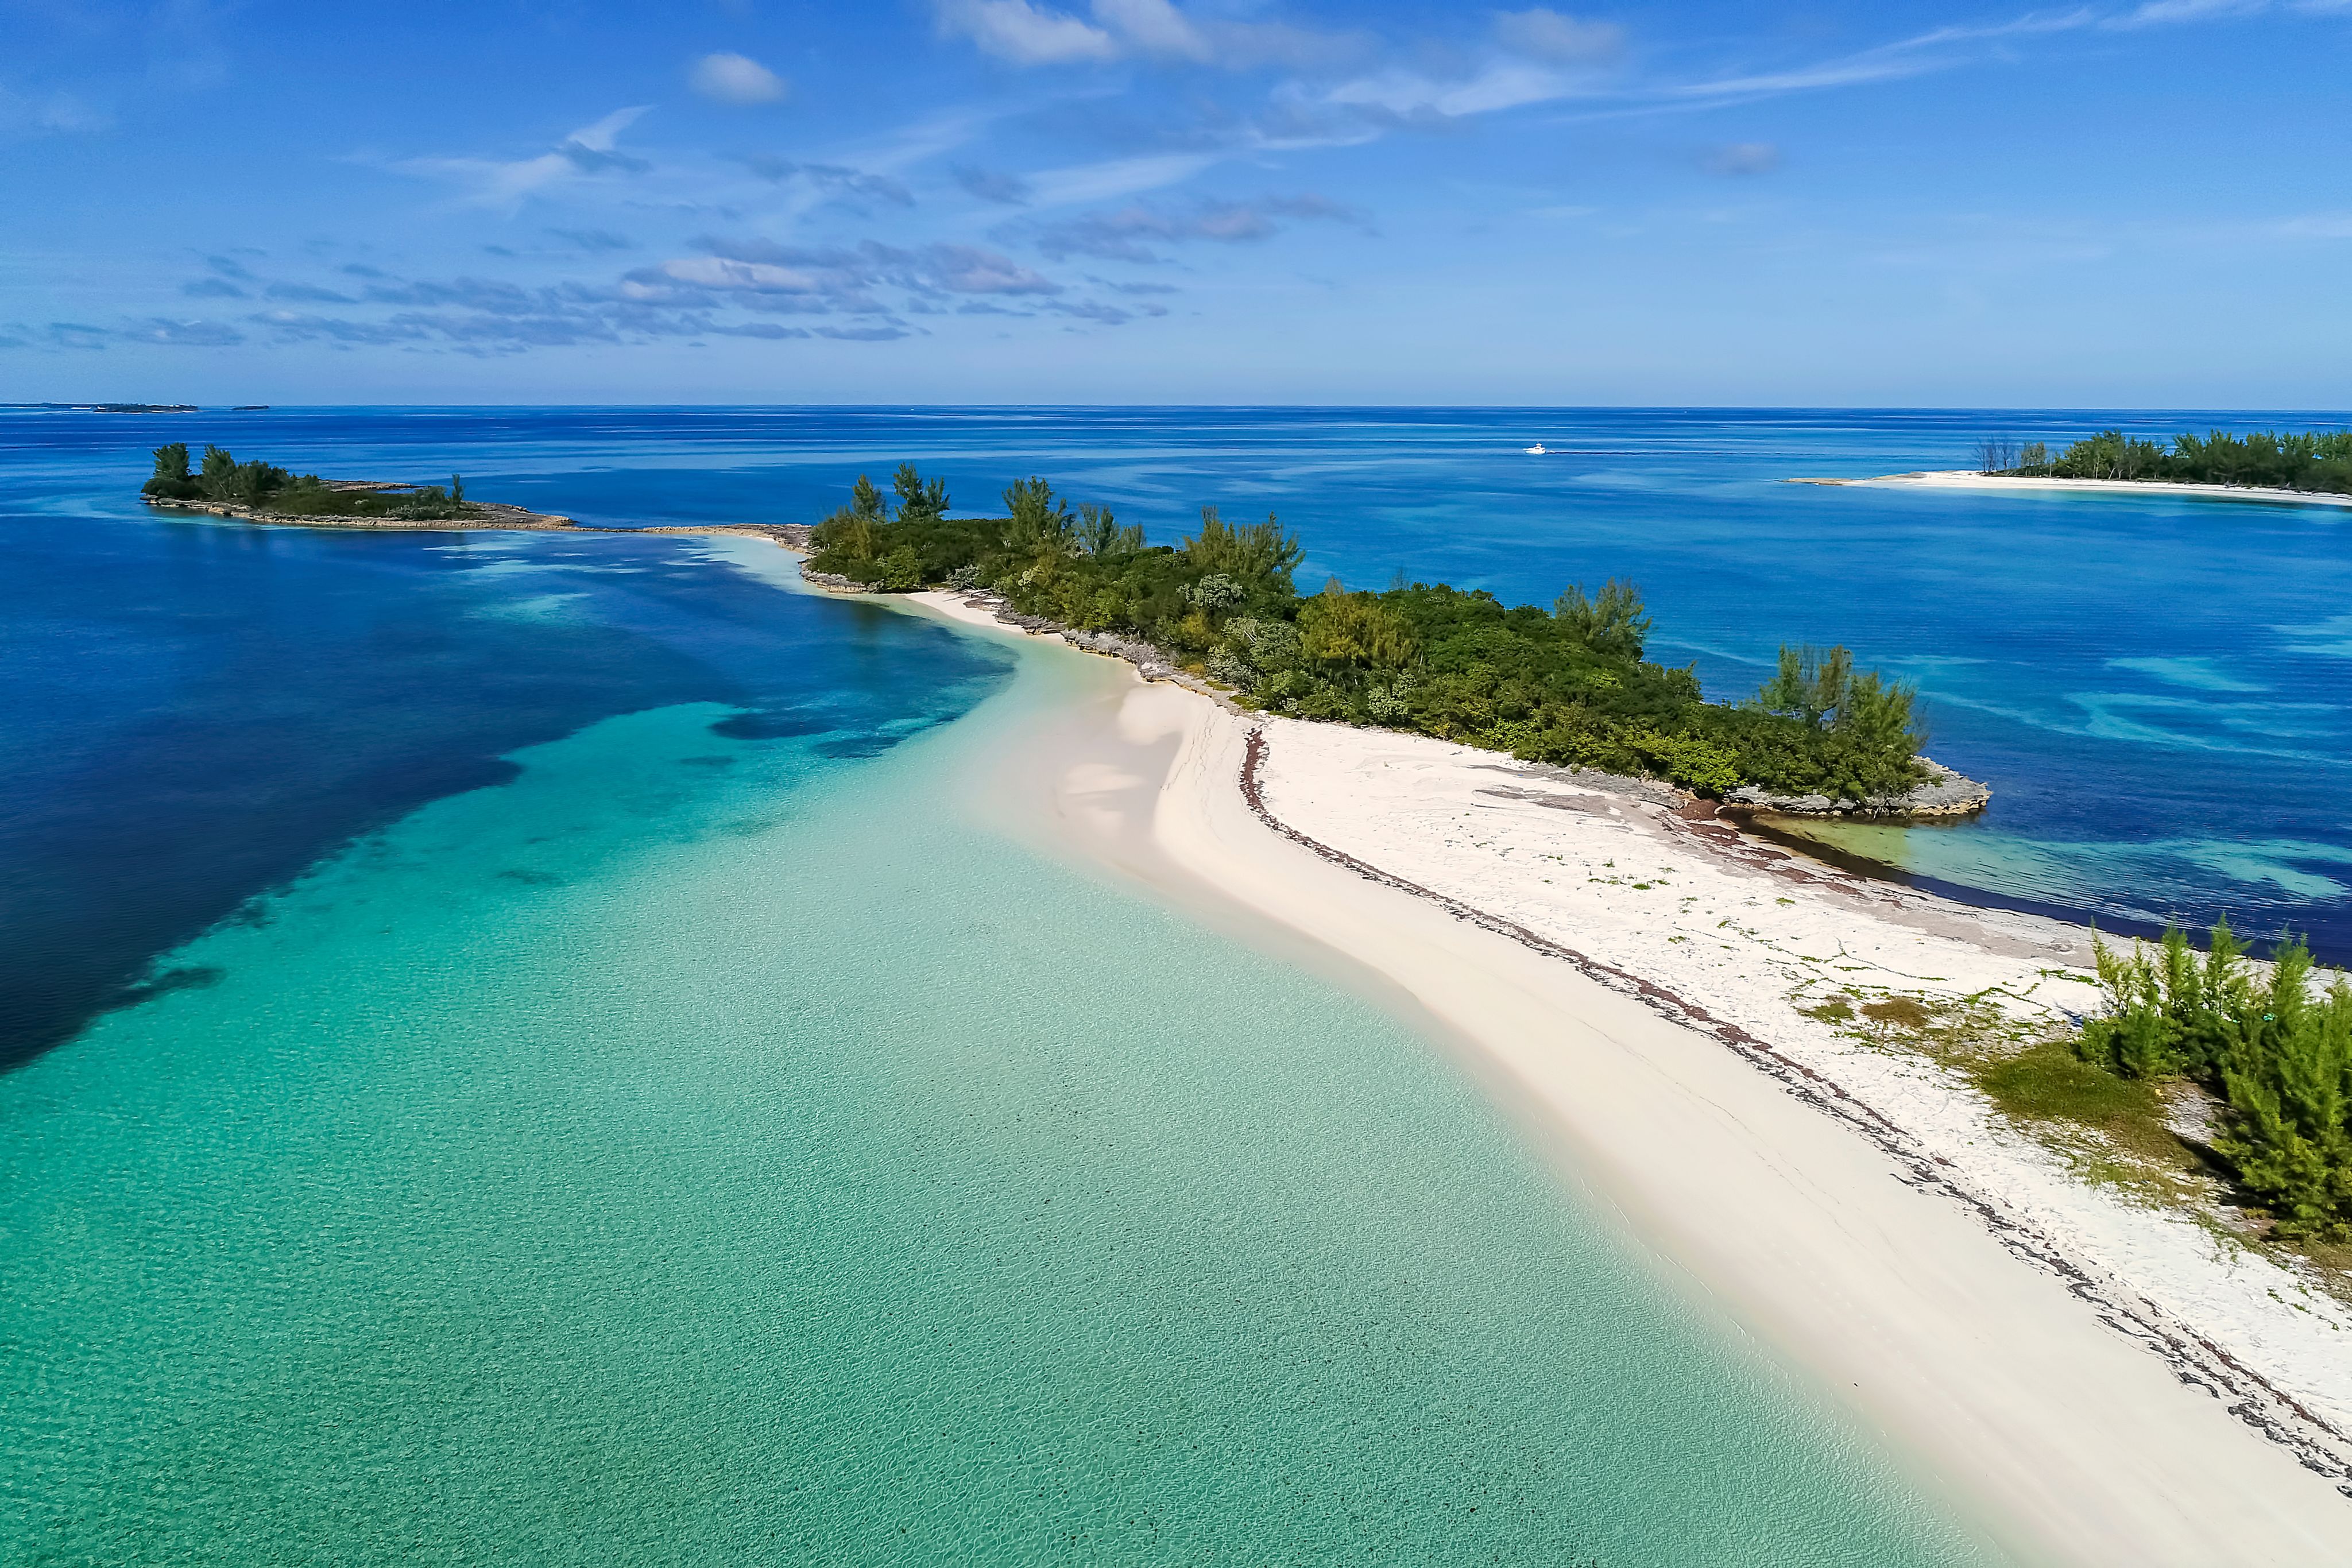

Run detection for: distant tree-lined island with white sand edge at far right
[[1790, 430, 2352, 505]]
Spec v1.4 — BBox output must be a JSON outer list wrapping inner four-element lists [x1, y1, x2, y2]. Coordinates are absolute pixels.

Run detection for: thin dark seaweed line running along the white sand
[[1240, 724, 2352, 1497]]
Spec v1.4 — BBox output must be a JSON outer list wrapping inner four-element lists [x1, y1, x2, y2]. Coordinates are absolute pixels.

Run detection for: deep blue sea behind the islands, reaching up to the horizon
[[0, 409, 2352, 959]]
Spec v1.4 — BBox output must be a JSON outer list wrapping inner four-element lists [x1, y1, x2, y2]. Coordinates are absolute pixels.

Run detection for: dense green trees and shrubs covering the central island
[[809, 463, 1927, 802]]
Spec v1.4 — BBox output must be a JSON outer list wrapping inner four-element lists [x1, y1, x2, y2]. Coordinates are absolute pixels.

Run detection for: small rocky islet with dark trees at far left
[[139, 442, 577, 529]]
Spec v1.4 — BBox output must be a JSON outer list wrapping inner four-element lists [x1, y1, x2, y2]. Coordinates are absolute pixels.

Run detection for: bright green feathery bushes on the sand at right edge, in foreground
[[2075, 924, 2352, 1241]]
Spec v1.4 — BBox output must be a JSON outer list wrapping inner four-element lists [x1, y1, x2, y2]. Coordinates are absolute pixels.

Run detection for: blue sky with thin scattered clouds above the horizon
[[0, 0, 2352, 409]]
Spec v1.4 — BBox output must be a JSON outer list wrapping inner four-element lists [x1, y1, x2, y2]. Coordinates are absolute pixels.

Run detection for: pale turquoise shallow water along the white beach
[[0, 585, 1983, 1568]]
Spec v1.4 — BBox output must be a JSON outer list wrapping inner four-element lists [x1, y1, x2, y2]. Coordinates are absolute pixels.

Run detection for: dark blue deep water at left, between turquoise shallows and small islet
[[0, 515, 1002, 1070]]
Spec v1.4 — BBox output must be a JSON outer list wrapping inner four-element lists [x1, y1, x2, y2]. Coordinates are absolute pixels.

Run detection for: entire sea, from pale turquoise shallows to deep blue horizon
[[0, 409, 2352, 1568]]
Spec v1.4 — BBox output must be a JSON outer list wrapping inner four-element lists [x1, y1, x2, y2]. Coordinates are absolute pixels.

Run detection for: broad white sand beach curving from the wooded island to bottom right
[[893, 595, 2352, 1566]]
